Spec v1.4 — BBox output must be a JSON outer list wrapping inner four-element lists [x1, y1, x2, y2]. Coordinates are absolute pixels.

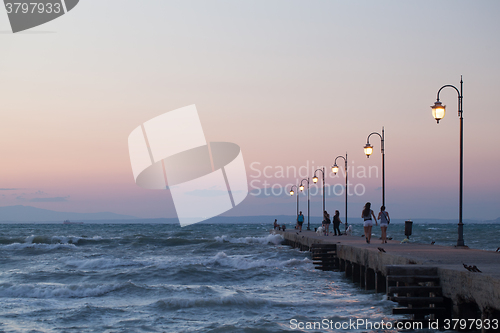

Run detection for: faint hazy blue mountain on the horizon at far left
[[0, 205, 137, 222]]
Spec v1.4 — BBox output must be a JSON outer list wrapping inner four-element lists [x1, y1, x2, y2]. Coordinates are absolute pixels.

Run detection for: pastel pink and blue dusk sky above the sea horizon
[[0, 0, 500, 220]]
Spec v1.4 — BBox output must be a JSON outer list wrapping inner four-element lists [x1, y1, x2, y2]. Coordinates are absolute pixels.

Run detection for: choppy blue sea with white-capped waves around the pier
[[0, 217, 500, 333]]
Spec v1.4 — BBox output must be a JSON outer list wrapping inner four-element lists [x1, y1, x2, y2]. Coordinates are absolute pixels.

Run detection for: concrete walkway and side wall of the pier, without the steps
[[272, 229, 500, 318]]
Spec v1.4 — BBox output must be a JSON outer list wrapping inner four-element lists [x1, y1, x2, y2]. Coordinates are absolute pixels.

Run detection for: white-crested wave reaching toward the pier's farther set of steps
[[208, 252, 312, 270]]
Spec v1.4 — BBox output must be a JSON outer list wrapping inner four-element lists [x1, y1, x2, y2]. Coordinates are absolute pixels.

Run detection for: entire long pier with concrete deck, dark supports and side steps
[[272, 229, 500, 332]]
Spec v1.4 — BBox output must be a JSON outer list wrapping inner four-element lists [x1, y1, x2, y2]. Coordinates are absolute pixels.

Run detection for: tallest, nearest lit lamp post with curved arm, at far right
[[431, 76, 465, 246]]
